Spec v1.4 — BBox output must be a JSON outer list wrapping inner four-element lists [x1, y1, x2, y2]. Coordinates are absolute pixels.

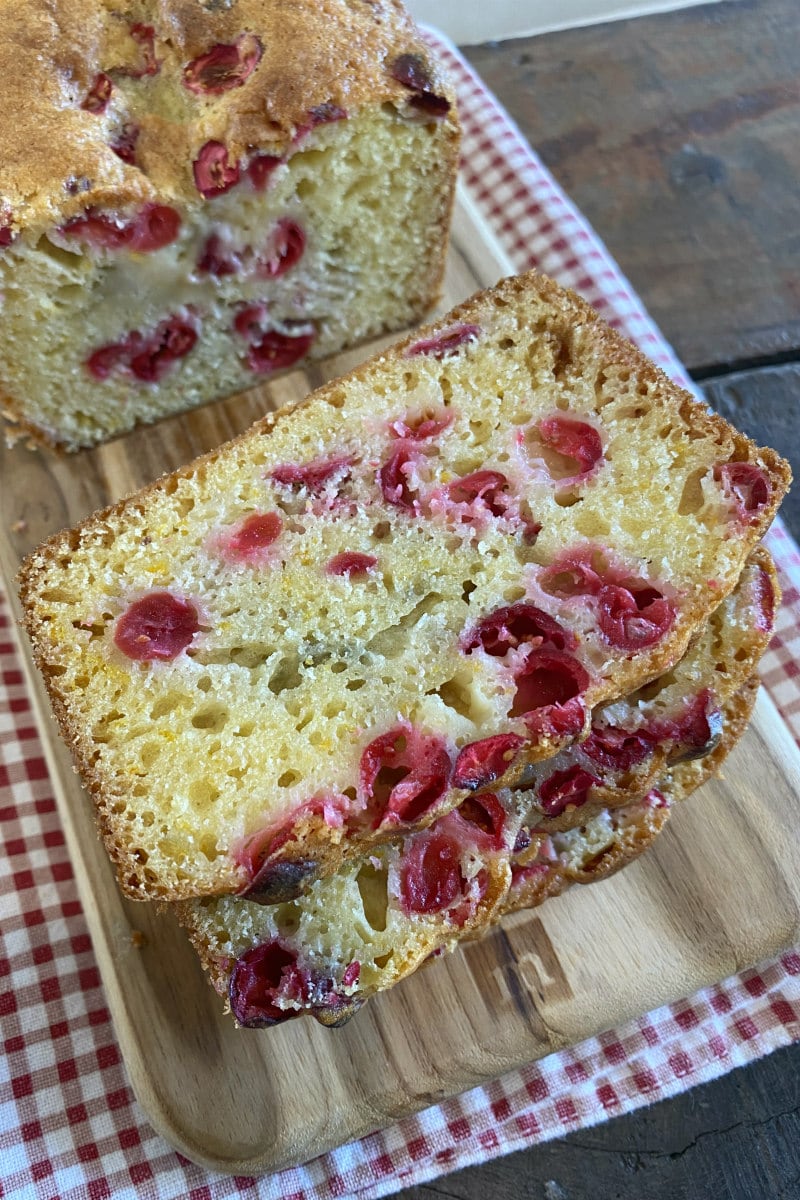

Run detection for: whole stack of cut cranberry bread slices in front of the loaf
[[22, 274, 789, 1025]]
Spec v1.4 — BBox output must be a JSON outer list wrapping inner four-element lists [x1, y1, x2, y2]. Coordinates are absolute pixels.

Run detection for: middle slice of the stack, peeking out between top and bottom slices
[[503, 546, 780, 833]]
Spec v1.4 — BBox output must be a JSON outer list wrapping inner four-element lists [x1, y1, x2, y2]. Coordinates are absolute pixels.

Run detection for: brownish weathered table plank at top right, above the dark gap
[[467, 0, 800, 374]]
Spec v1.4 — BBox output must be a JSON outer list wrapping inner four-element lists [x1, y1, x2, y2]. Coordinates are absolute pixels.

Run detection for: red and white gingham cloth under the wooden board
[[0, 34, 800, 1200]]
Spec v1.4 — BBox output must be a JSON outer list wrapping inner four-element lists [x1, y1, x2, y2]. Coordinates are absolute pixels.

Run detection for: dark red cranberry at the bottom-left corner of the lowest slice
[[229, 940, 307, 1030]]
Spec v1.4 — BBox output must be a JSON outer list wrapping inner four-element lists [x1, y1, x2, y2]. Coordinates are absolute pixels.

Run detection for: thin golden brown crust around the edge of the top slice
[[19, 272, 790, 900]]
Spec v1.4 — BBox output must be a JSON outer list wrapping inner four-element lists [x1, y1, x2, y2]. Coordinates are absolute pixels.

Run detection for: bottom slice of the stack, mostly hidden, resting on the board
[[175, 680, 758, 1028]]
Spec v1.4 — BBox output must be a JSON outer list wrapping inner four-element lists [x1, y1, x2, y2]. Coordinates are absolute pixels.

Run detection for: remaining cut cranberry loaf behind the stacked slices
[[0, 0, 458, 449]]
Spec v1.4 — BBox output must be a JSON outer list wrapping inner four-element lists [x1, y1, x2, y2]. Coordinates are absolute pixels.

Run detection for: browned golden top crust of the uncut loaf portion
[[0, 0, 452, 236]]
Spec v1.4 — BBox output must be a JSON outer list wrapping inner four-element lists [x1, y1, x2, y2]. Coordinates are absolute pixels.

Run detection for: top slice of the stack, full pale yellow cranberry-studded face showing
[[22, 274, 788, 900]]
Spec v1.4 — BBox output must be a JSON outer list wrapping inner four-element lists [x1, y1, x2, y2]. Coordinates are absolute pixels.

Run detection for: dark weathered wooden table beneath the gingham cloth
[[402, 0, 800, 1200]]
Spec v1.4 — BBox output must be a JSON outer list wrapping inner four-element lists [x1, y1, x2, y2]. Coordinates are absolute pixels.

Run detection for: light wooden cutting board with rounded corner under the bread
[[0, 187, 800, 1174]]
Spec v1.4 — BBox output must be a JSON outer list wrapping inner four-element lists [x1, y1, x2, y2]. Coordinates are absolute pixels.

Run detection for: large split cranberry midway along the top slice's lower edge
[[360, 722, 451, 826]]
